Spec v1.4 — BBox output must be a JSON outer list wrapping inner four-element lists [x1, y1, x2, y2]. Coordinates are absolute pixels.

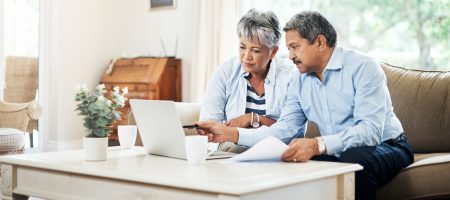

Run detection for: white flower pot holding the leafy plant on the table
[[83, 137, 108, 161]]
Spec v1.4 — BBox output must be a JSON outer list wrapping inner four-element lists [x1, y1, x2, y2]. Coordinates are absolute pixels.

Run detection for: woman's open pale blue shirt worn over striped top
[[200, 57, 296, 122]]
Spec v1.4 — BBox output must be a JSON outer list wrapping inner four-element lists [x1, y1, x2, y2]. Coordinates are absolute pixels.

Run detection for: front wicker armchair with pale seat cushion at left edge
[[0, 101, 42, 155]]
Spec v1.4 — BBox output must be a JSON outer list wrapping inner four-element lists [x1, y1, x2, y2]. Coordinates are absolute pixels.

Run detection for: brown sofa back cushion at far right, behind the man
[[382, 64, 450, 153]]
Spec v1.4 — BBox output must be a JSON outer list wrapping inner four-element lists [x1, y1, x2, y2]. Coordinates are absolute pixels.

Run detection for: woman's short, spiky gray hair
[[237, 9, 281, 48]]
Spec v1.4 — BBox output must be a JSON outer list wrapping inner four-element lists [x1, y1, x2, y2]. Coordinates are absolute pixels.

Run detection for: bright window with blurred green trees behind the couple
[[241, 0, 450, 71]]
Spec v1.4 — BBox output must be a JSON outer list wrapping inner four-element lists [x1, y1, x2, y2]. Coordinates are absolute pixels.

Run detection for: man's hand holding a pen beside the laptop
[[195, 121, 239, 143]]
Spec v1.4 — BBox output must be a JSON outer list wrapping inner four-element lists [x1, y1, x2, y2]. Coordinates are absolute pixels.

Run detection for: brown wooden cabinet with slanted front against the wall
[[101, 57, 181, 141]]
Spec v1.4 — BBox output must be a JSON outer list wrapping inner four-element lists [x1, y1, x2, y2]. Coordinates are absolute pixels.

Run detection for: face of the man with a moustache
[[286, 30, 320, 74]]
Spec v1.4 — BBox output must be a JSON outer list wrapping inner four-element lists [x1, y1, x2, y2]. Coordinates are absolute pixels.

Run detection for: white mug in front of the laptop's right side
[[185, 135, 208, 165]]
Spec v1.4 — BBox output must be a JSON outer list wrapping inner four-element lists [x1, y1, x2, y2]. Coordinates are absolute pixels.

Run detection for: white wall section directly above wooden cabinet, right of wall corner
[[123, 0, 198, 101]]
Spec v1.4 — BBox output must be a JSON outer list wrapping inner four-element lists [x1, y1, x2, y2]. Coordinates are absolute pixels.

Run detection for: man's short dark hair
[[283, 11, 337, 47]]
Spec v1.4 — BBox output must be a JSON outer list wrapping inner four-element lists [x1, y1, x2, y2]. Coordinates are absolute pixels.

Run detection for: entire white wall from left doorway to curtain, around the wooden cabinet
[[45, 0, 197, 150]]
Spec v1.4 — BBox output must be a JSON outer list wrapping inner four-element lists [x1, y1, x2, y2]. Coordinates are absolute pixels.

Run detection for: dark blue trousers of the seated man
[[312, 134, 414, 200]]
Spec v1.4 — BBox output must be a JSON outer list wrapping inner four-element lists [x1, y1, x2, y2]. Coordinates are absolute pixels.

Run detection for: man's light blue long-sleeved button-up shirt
[[238, 47, 403, 156]]
